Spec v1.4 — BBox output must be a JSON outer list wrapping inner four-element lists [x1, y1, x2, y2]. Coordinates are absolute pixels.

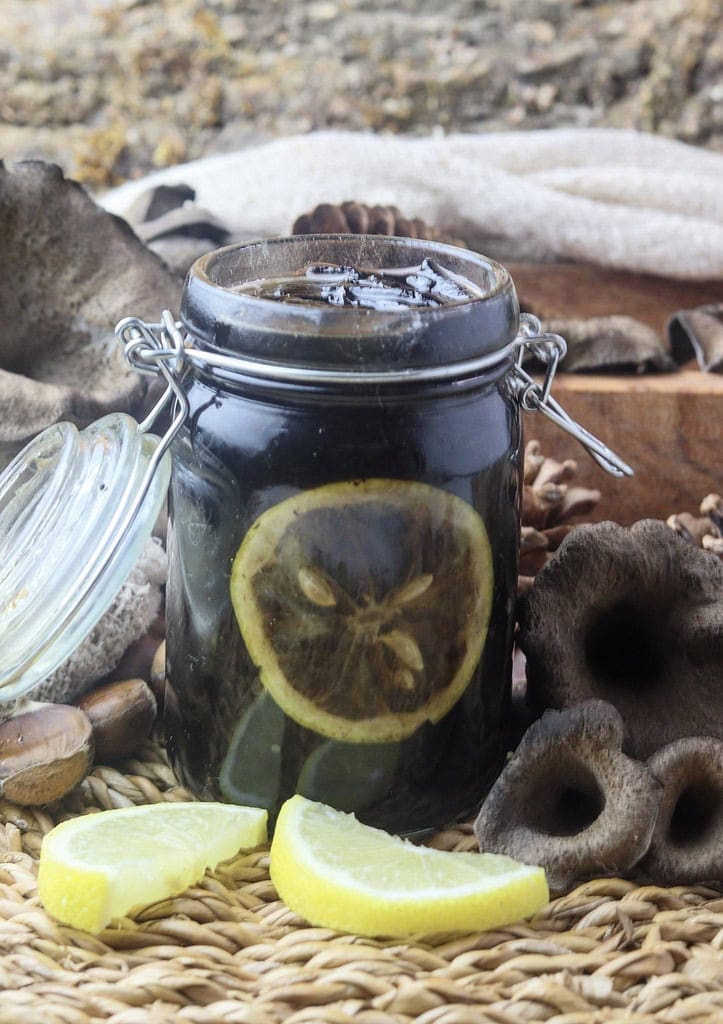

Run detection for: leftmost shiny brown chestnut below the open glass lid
[[0, 703, 93, 807]]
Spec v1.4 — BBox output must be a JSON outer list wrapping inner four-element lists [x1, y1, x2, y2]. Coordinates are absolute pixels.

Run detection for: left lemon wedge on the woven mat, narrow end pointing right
[[38, 803, 267, 932]]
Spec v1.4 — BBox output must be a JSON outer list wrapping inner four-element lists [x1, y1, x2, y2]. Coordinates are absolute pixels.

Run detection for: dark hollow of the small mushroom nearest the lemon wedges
[[526, 762, 605, 836]]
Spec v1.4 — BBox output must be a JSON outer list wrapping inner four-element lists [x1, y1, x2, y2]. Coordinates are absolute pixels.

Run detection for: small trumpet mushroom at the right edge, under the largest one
[[640, 736, 723, 886]]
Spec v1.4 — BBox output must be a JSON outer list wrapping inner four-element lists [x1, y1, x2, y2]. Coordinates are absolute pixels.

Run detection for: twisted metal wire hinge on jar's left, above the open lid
[[116, 309, 188, 464]]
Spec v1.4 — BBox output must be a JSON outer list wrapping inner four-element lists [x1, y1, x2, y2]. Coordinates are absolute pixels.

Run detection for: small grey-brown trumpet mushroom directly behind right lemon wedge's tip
[[474, 700, 658, 891]]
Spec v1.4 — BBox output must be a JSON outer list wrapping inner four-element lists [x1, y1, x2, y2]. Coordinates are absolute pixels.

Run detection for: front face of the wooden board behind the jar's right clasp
[[524, 370, 723, 525]]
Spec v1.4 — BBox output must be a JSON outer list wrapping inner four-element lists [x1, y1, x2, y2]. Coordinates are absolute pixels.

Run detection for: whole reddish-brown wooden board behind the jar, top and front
[[507, 263, 723, 525]]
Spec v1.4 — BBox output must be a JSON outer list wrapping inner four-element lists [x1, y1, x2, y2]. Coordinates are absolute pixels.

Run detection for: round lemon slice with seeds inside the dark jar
[[230, 479, 493, 742]]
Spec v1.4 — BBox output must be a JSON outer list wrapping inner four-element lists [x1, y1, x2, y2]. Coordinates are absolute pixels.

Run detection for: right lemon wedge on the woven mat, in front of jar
[[270, 795, 549, 938]]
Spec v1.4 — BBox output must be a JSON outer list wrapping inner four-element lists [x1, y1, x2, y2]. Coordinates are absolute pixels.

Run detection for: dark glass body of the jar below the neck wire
[[166, 375, 521, 834]]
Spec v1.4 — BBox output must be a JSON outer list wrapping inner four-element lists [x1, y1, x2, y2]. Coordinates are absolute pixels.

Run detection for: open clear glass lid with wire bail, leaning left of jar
[[0, 311, 187, 706]]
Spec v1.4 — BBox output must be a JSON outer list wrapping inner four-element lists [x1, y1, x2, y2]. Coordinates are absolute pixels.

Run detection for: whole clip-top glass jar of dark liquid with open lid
[[0, 236, 631, 834]]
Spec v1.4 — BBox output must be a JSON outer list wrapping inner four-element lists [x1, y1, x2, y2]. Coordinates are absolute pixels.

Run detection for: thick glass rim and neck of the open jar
[[180, 234, 519, 374]]
